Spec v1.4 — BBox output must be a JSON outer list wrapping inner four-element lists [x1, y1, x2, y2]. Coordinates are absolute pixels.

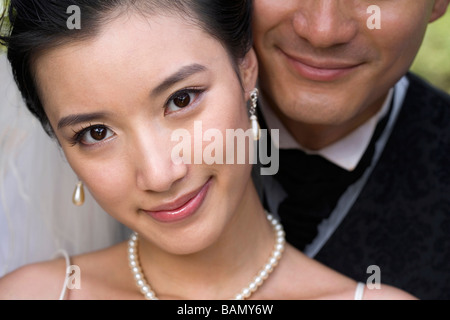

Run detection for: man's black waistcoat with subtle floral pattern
[[256, 74, 450, 299]]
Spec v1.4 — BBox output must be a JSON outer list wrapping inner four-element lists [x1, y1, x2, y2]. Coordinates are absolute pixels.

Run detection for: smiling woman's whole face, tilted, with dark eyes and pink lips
[[35, 11, 256, 253]]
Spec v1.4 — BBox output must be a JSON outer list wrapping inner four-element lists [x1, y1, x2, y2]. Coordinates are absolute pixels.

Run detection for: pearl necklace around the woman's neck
[[128, 214, 286, 300]]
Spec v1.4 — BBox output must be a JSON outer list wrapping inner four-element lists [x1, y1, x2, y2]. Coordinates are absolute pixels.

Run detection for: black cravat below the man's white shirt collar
[[260, 96, 392, 250]]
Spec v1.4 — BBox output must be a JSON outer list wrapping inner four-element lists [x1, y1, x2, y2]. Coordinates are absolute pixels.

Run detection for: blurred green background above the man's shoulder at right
[[0, 0, 450, 93]]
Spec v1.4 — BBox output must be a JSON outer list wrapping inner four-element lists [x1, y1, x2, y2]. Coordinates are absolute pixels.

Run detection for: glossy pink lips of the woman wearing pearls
[[143, 179, 211, 222]]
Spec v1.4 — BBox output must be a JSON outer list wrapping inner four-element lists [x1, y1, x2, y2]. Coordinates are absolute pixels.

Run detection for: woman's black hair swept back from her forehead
[[0, 0, 252, 136]]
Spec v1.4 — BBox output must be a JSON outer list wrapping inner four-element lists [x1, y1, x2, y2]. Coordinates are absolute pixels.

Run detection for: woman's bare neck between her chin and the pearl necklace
[[135, 181, 275, 300]]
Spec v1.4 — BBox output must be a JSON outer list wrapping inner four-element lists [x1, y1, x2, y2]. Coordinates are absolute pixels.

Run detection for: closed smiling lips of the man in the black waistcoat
[[280, 50, 361, 82]]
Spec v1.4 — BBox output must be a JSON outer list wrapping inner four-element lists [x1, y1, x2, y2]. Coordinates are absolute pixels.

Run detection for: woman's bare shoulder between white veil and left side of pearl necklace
[[0, 243, 130, 300]]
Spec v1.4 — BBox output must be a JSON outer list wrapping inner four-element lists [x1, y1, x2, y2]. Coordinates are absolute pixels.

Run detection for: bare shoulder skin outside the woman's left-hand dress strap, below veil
[[0, 258, 66, 300]]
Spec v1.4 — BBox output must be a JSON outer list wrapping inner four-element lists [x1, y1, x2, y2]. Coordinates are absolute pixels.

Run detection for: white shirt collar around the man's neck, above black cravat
[[259, 77, 407, 171]]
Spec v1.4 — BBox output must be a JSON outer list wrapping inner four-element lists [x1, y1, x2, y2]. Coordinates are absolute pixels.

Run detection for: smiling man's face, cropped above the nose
[[254, 0, 450, 125]]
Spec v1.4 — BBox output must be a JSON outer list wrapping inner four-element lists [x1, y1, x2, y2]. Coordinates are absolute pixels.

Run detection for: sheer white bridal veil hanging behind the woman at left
[[0, 51, 128, 277]]
